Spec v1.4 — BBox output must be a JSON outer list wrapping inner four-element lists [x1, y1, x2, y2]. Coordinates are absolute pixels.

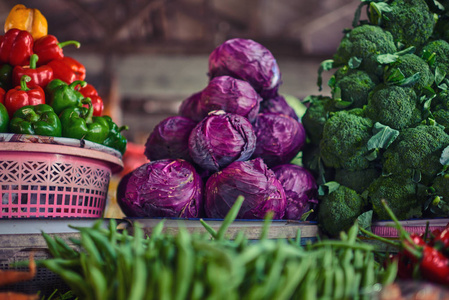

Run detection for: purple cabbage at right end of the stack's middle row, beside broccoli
[[253, 113, 306, 168]]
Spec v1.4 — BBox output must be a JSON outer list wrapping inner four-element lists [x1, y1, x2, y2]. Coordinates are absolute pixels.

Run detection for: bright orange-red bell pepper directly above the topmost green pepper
[[47, 56, 86, 84]]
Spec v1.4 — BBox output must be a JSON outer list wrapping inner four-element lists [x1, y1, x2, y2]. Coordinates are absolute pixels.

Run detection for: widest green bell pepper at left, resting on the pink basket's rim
[[9, 104, 61, 137]]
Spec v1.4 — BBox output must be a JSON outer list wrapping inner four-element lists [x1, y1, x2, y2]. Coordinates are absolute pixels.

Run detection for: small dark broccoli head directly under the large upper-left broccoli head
[[331, 68, 377, 108]]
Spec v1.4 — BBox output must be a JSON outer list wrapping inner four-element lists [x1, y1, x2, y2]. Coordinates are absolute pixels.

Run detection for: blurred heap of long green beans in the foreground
[[37, 198, 397, 300]]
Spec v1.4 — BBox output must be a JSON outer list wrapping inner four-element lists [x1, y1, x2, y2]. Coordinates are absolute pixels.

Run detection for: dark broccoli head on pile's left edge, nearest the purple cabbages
[[301, 96, 335, 145]]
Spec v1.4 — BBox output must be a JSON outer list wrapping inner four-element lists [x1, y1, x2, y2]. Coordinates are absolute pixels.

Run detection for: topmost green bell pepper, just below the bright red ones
[[45, 79, 87, 115]]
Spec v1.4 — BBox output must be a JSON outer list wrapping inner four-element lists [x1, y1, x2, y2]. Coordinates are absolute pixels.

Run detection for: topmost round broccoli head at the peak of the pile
[[382, 0, 435, 48]]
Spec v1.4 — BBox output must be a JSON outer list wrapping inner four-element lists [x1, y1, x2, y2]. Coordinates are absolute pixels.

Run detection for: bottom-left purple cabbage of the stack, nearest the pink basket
[[117, 159, 203, 218]]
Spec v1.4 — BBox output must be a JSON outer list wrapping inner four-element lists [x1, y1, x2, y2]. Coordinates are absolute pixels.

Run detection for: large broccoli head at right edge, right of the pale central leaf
[[383, 125, 449, 183]]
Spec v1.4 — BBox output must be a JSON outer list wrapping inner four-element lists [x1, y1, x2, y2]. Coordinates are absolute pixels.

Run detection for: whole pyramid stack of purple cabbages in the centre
[[117, 39, 317, 220]]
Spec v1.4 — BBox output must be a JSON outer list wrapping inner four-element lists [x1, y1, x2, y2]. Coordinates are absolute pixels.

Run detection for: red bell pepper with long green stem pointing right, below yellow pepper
[[33, 34, 81, 66]]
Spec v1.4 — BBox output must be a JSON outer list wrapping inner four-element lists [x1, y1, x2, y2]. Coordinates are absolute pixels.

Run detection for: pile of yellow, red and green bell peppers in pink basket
[[0, 4, 128, 154]]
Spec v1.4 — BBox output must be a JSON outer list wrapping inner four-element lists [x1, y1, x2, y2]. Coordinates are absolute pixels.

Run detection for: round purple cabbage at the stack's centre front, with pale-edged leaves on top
[[189, 110, 256, 172]]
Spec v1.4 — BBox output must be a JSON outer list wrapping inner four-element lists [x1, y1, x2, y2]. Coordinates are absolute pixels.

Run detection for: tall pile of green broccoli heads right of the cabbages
[[302, 0, 449, 236]]
